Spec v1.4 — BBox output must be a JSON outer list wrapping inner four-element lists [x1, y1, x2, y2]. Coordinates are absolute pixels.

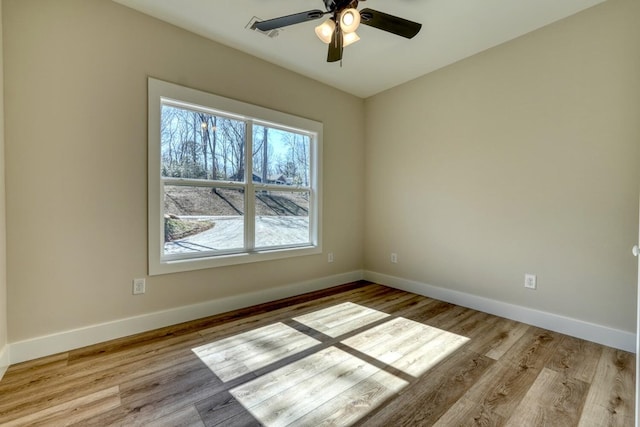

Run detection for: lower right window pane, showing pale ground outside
[[255, 191, 309, 248]]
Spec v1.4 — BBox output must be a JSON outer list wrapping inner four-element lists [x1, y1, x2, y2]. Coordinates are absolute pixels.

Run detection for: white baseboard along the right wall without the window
[[364, 271, 636, 353]]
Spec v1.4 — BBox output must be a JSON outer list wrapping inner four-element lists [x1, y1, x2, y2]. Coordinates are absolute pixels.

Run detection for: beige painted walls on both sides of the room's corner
[[0, 0, 640, 345]]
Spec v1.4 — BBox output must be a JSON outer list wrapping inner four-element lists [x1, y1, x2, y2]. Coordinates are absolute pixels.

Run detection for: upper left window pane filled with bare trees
[[160, 104, 246, 182]]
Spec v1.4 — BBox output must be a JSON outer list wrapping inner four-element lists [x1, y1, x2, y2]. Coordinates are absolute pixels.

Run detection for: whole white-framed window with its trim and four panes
[[148, 78, 322, 275]]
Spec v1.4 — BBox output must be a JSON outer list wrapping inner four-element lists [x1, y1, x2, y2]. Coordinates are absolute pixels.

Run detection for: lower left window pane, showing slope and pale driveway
[[164, 185, 244, 255]]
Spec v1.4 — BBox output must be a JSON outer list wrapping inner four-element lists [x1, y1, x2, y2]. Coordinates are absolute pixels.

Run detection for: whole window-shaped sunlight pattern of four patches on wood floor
[[193, 302, 469, 426]]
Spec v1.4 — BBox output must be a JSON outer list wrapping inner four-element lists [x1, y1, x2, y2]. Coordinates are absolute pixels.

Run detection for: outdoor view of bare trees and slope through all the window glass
[[160, 104, 311, 254]]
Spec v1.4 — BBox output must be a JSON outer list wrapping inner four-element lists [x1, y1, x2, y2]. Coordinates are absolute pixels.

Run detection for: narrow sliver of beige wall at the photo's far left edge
[[0, 0, 8, 364]]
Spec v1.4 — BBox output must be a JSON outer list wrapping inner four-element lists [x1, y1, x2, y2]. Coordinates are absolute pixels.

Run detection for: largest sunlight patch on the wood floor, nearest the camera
[[231, 347, 408, 426]]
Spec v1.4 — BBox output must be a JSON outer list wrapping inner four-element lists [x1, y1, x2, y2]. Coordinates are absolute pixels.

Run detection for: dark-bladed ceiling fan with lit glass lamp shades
[[252, 0, 422, 62]]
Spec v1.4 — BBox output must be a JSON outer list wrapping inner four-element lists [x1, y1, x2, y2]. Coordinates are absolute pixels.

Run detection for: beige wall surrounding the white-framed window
[[4, 0, 364, 342]]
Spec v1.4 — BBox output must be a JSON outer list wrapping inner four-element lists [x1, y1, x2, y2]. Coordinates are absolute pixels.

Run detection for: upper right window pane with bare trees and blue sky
[[253, 125, 311, 187]]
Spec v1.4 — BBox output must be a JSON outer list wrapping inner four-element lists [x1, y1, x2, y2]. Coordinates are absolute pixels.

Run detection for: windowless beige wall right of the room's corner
[[364, 0, 640, 332]]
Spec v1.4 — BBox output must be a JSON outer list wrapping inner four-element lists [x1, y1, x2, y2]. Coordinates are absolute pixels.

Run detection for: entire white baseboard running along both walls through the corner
[[6, 270, 636, 364]]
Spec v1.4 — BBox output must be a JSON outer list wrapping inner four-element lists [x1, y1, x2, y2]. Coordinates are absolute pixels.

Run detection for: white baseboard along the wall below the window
[[7, 270, 362, 364]]
